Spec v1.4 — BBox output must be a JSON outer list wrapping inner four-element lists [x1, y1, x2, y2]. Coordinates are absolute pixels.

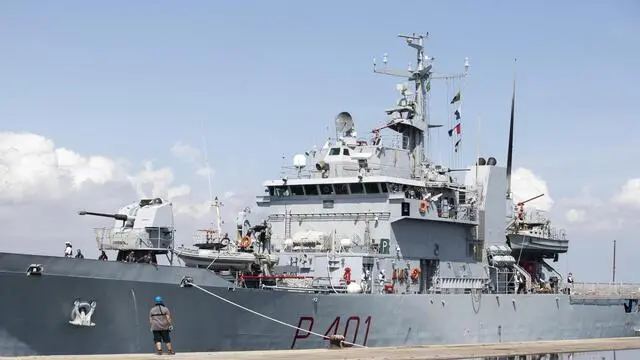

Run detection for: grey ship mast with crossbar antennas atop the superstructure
[[373, 33, 469, 178]]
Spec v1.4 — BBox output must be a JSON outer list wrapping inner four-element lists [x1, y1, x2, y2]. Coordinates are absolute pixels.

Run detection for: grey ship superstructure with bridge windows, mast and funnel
[[249, 35, 524, 294]]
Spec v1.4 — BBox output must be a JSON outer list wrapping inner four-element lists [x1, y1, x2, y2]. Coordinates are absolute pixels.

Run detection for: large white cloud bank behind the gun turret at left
[[0, 132, 262, 257]]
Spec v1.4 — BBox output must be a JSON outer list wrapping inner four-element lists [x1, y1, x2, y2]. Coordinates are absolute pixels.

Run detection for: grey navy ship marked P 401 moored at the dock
[[0, 34, 640, 355]]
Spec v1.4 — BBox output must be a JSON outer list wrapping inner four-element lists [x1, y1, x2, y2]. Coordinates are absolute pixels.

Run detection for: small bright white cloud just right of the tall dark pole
[[511, 168, 553, 211]]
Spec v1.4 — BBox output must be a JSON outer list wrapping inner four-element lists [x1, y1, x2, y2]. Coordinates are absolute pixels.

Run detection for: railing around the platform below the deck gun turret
[[94, 228, 173, 250]]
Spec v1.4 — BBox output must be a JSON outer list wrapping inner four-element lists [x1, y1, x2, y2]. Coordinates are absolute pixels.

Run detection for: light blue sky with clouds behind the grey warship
[[0, 0, 640, 282]]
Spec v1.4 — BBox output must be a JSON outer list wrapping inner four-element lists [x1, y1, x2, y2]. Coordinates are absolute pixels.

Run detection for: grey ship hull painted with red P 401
[[0, 253, 640, 356]]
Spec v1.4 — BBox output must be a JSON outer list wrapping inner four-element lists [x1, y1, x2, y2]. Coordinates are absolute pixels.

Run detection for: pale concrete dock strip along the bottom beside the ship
[[5, 337, 640, 360]]
